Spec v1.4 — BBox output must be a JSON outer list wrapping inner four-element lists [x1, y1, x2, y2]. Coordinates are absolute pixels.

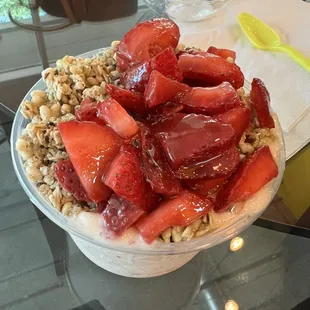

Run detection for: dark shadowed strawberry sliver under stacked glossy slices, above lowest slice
[[183, 177, 227, 196]]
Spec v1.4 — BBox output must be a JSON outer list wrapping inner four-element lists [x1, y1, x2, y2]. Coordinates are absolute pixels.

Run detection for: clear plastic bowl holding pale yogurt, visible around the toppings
[[11, 49, 285, 278]]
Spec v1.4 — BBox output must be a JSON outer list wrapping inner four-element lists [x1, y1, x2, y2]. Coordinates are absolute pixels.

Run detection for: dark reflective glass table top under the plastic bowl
[[0, 1, 310, 310]]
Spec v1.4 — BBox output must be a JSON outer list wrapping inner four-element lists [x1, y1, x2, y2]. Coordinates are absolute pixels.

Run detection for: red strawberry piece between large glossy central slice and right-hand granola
[[215, 106, 251, 144]]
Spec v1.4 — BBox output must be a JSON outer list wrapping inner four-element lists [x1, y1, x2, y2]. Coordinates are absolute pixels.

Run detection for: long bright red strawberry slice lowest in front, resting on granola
[[135, 191, 213, 243]]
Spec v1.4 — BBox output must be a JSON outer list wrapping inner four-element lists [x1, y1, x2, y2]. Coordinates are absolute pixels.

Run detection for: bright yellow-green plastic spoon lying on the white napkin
[[238, 13, 310, 71]]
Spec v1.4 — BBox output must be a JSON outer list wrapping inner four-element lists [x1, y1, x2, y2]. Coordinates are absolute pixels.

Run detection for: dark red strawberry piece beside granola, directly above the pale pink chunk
[[105, 84, 147, 114]]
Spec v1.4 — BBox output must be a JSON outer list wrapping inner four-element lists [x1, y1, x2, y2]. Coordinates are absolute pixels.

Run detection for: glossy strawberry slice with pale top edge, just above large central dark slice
[[180, 82, 241, 116]]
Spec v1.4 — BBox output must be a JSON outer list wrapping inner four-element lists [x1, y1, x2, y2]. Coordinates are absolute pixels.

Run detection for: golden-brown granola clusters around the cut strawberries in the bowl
[[16, 41, 276, 242]]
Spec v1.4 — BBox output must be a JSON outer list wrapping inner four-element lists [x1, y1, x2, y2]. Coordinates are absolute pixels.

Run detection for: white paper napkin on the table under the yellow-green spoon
[[178, 0, 310, 158]]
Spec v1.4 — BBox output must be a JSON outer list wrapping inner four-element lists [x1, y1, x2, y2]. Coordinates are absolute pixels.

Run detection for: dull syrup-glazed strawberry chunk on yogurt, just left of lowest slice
[[101, 194, 145, 236]]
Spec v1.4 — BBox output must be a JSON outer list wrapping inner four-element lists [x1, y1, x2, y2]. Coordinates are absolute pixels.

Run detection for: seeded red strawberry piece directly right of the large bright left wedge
[[104, 145, 157, 211]]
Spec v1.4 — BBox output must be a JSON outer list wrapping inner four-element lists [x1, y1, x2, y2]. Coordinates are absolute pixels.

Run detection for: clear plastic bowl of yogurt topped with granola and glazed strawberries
[[11, 19, 285, 277]]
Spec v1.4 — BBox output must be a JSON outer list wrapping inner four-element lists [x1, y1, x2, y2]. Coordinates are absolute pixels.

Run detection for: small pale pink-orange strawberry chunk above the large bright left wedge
[[97, 98, 139, 139]]
